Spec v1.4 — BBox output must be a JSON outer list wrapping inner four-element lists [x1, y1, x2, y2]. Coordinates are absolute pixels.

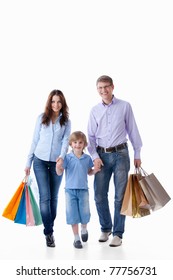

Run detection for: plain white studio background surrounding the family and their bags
[[0, 0, 173, 279]]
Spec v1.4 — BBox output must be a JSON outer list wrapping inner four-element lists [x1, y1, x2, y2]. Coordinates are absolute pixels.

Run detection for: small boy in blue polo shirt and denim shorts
[[56, 131, 99, 249]]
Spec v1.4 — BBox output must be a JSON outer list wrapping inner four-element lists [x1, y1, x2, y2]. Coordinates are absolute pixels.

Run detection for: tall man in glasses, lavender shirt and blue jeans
[[88, 75, 142, 247]]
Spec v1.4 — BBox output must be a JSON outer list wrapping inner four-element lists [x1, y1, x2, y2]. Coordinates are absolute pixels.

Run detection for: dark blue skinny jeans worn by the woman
[[33, 157, 62, 235]]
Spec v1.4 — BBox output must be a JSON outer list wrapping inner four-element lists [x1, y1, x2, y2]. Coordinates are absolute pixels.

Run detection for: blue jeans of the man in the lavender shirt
[[94, 147, 130, 238]]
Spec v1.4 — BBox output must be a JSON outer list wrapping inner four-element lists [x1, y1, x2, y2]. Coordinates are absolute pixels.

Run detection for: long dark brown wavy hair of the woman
[[42, 89, 69, 126]]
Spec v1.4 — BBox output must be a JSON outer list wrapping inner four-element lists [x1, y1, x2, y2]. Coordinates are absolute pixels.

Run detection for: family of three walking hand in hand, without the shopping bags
[[25, 75, 142, 249]]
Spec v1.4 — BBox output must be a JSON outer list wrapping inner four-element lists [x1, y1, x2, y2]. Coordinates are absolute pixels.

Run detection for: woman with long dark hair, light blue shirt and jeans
[[25, 90, 71, 247]]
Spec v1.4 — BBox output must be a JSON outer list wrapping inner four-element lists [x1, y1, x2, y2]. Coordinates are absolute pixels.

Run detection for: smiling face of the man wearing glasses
[[97, 82, 114, 104]]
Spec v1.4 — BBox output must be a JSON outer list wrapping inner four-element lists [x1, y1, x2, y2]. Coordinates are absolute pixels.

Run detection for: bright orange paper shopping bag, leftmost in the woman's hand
[[2, 180, 26, 221]]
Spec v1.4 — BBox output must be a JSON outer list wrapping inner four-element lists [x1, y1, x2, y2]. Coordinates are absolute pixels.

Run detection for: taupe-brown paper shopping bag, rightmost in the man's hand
[[139, 168, 171, 211]]
